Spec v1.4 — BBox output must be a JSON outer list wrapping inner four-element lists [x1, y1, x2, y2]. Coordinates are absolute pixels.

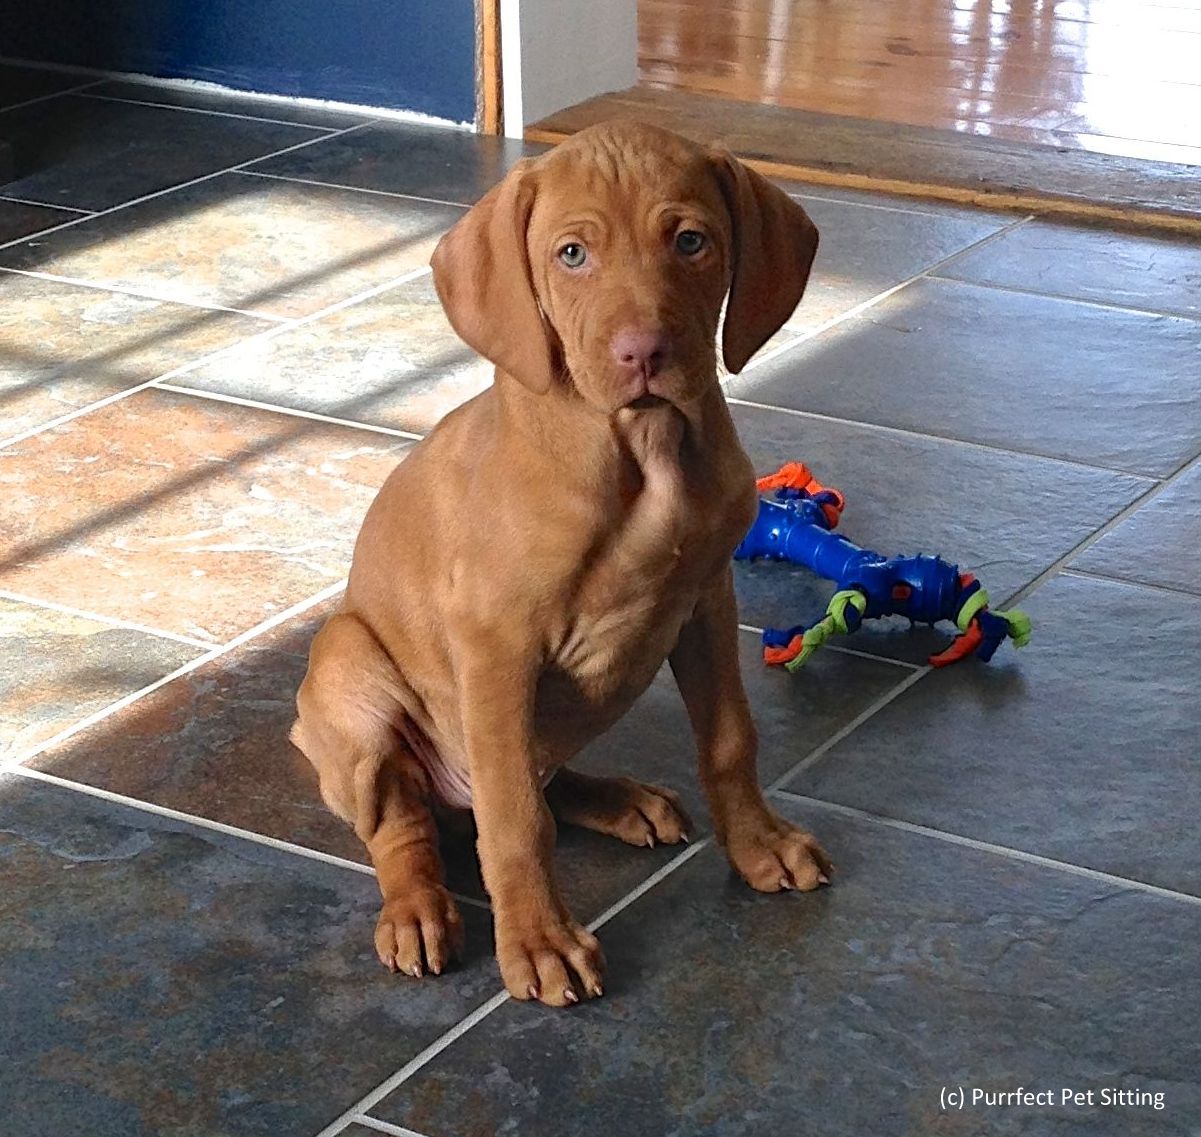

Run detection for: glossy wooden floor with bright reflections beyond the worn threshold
[[639, 0, 1201, 164]]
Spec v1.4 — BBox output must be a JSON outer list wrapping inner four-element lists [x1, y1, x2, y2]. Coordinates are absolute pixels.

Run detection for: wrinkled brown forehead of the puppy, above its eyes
[[533, 130, 725, 226]]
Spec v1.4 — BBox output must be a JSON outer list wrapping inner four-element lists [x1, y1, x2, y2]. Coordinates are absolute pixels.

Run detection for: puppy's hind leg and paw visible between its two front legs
[[546, 767, 692, 845]]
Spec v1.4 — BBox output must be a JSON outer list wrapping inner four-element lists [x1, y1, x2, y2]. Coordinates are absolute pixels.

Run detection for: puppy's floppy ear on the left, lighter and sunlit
[[430, 160, 555, 395]]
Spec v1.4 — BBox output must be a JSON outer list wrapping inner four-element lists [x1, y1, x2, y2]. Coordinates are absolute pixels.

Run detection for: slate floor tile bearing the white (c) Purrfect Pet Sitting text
[[371, 807, 1201, 1137]]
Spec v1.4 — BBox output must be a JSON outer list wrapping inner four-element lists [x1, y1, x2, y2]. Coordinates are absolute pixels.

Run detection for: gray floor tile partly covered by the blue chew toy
[[734, 403, 1153, 670]]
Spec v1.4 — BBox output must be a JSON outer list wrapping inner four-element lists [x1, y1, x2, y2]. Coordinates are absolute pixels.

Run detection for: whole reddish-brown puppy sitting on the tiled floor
[[292, 124, 830, 1006]]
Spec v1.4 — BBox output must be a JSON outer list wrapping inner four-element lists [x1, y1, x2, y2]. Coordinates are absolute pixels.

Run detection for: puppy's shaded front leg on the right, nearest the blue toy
[[670, 570, 831, 892]]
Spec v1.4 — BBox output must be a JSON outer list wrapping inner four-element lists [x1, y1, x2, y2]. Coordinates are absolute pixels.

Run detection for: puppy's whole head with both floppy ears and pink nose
[[432, 122, 818, 413]]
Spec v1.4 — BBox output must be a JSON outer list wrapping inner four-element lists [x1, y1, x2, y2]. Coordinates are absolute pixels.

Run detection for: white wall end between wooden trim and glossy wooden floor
[[501, 0, 638, 138]]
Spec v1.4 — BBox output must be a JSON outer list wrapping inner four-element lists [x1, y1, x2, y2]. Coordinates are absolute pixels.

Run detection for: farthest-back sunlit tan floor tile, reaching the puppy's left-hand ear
[[0, 171, 462, 318]]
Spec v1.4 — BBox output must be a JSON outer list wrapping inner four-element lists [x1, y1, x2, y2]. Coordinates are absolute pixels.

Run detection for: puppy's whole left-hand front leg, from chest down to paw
[[456, 639, 604, 1006]]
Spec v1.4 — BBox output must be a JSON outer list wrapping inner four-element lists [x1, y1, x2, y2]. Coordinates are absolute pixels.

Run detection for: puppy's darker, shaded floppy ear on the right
[[712, 151, 818, 375]]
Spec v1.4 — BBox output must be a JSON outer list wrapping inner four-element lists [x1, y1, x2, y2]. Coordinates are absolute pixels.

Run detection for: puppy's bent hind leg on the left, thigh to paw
[[292, 612, 464, 976]]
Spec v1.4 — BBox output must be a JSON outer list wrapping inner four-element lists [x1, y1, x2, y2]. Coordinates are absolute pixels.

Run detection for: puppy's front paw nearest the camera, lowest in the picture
[[496, 917, 604, 1006]]
